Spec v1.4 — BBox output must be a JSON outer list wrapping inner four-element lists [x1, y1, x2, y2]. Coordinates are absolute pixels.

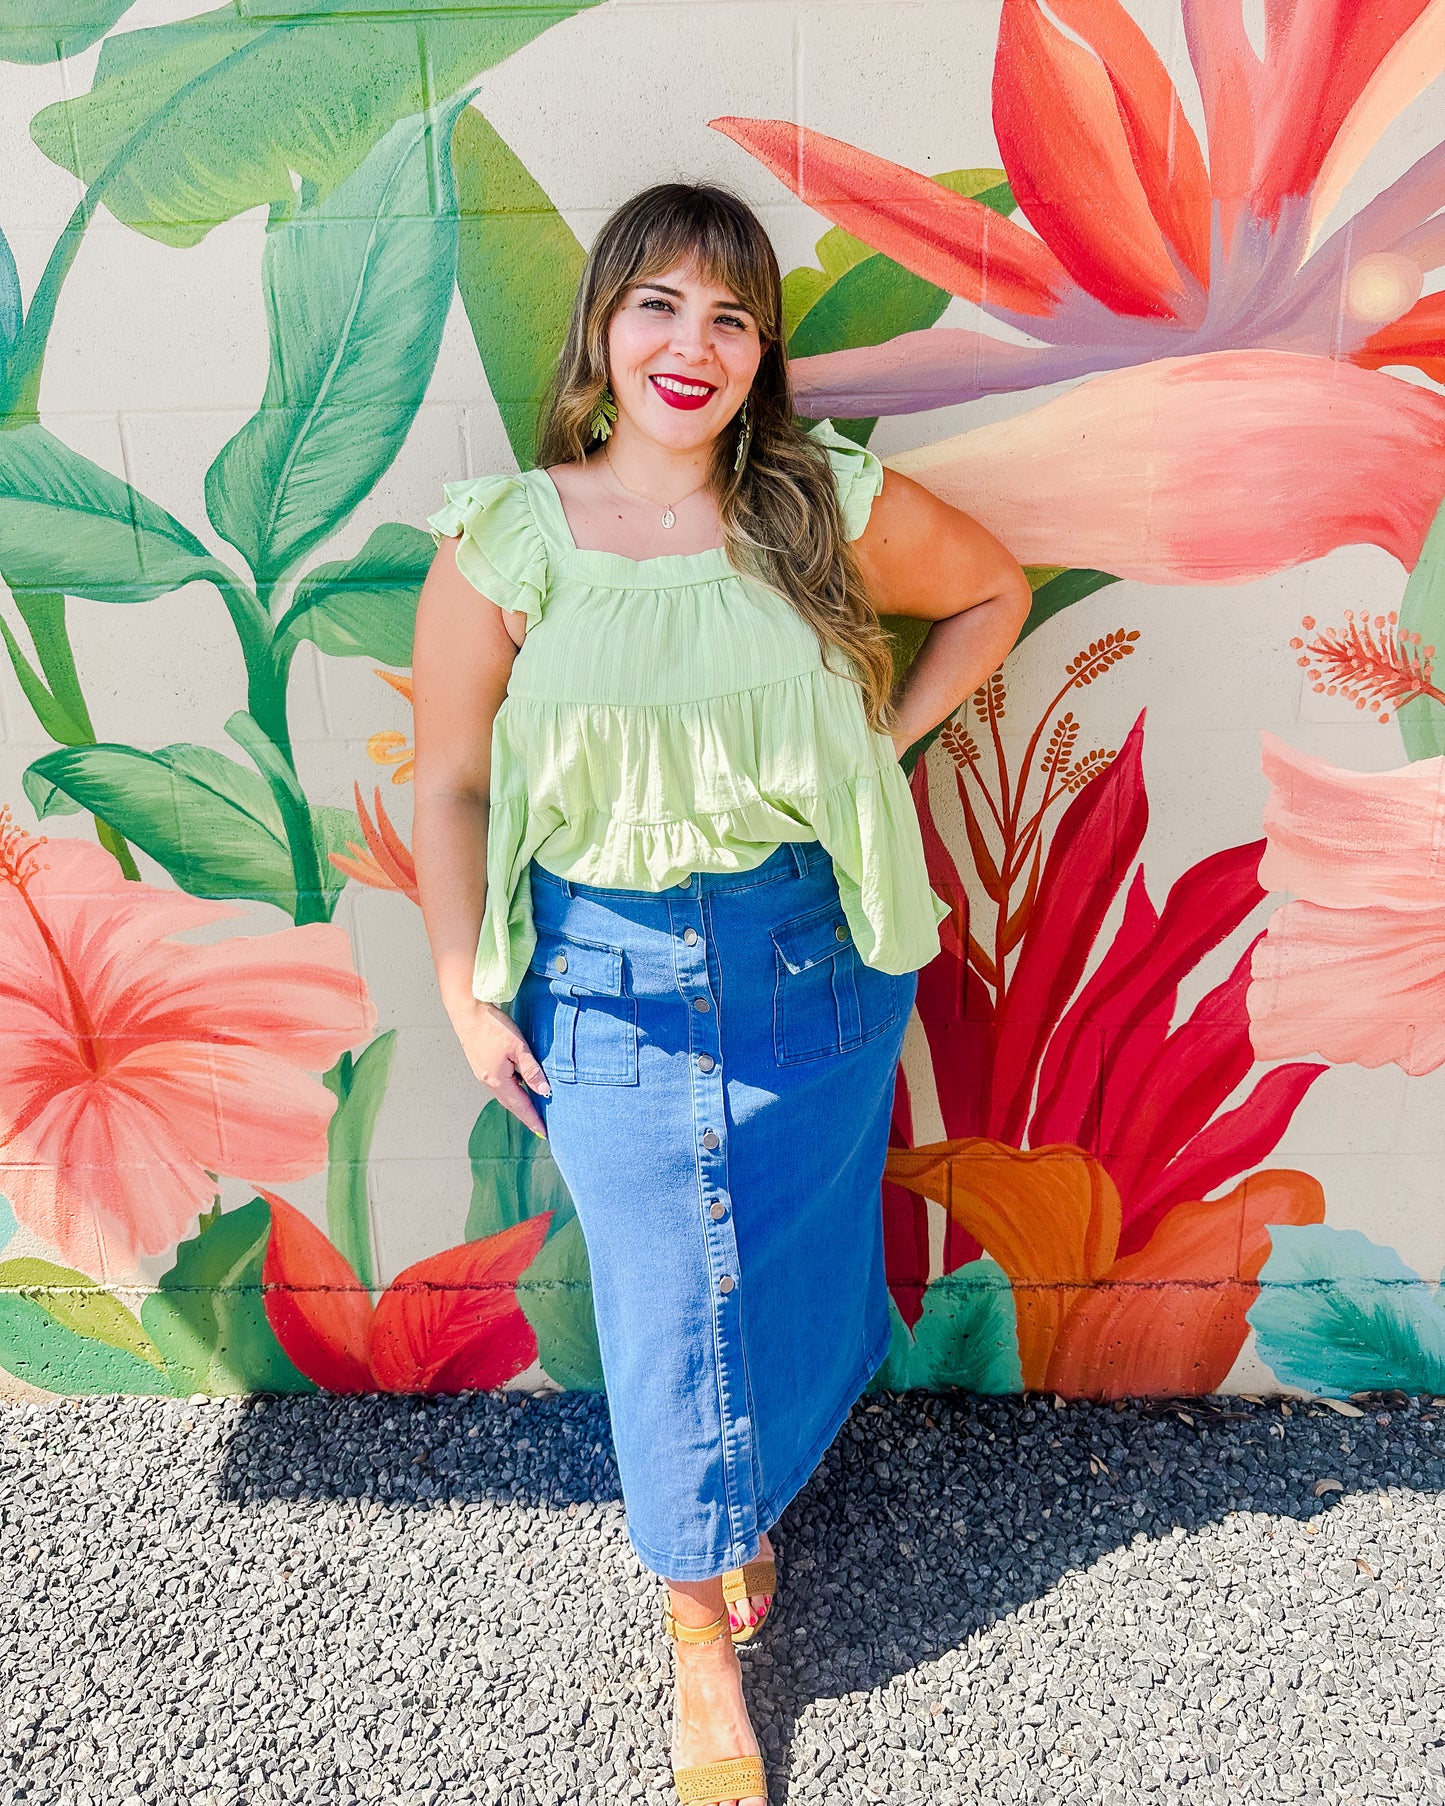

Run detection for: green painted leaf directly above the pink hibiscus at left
[[22, 744, 301, 916]]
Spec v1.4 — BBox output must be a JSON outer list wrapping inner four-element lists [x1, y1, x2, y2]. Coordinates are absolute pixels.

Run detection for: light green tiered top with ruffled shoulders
[[426, 421, 948, 1004]]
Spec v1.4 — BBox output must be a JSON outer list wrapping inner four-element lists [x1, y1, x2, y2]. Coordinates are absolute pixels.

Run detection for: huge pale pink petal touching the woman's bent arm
[[887, 350, 1445, 583]]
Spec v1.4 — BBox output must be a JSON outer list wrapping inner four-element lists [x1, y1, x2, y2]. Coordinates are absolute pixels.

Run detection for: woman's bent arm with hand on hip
[[853, 470, 1031, 757]]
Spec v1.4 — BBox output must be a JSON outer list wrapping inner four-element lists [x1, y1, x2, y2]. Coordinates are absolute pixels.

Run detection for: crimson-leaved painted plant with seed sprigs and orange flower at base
[[885, 657, 1326, 1398]]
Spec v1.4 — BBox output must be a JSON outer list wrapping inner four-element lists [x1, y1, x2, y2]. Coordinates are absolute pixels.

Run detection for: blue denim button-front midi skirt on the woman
[[511, 840, 918, 1580]]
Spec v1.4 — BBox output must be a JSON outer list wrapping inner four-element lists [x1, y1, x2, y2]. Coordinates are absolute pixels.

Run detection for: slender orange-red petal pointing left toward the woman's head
[[708, 119, 1073, 318]]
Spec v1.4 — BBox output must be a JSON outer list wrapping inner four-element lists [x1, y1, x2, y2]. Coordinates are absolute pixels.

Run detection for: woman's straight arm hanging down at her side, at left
[[412, 538, 549, 1134]]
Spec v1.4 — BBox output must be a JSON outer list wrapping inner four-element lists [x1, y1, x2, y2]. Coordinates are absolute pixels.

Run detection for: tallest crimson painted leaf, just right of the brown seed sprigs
[[989, 715, 1149, 1147]]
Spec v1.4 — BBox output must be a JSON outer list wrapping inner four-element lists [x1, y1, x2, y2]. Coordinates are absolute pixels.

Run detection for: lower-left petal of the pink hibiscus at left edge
[[0, 1084, 215, 1279]]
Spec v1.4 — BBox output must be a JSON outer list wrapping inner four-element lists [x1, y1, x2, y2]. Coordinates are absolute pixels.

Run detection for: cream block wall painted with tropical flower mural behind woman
[[0, 0, 1445, 1398]]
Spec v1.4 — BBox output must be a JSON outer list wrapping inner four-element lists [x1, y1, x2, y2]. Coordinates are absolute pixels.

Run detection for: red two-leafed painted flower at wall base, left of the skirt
[[262, 1192, 551, 1392]]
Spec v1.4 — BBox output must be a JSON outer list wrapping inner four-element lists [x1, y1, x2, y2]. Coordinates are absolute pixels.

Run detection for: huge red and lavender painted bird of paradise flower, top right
[[712, 0, 1445, 415]]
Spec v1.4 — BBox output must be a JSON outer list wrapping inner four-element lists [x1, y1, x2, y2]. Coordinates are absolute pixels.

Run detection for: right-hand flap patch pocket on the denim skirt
[[771, 903, 898, 1066]]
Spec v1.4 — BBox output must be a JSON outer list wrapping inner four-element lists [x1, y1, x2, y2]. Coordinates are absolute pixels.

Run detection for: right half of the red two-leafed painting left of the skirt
[[372, 1210, 553, 1392]]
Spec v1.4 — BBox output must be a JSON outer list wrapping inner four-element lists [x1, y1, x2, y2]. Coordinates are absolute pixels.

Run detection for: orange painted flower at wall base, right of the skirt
[[887, 1136, 1324, 1398]]
